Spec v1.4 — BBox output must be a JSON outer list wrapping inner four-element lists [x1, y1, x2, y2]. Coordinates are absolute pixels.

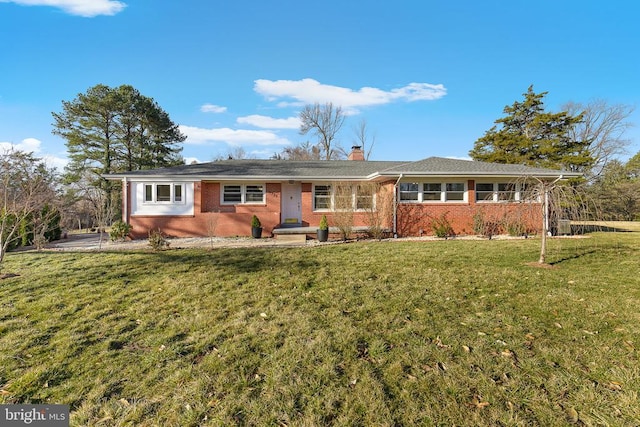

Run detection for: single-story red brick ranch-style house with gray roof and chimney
[[106, 146, 579, 238]]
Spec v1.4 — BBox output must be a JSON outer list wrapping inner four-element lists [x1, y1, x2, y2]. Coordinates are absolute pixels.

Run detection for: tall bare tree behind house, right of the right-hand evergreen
[[563, 99, 634, 180]]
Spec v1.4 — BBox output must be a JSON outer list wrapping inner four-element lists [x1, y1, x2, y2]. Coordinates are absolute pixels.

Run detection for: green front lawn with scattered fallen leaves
[[0, 233, 640, 426]]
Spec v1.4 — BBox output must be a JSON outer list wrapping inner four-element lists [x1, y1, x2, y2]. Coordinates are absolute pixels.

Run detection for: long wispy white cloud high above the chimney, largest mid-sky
[[254, 79, 447, 111]]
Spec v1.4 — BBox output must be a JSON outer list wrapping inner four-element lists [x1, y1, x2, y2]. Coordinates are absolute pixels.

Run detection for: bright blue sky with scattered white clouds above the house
[[0, 0, 640, 166]]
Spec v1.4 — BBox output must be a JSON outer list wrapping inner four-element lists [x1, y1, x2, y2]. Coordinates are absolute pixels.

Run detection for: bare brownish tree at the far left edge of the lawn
[[0, 150, 59, 266]]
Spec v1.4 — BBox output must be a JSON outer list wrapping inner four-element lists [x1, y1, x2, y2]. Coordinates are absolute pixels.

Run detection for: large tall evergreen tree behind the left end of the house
[[53, 84, 186, 224]]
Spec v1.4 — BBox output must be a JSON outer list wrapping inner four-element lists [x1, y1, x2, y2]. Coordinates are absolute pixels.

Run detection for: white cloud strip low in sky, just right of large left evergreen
[[180, 125, 290, 146]]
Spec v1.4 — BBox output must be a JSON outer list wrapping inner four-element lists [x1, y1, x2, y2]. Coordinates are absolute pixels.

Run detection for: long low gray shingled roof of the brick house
[[106, 157, 579, 180]]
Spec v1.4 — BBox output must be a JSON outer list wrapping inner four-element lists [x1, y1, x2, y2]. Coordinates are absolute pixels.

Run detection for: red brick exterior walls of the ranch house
[[127, 180, 542, 238]]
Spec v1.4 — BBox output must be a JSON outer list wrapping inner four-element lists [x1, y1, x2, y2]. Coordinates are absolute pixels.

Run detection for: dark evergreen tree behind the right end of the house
[[469, 86, 593, 172]]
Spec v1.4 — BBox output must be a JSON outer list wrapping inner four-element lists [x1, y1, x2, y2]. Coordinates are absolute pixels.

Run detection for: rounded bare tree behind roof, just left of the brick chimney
[[300, 102, 345, 160]]
